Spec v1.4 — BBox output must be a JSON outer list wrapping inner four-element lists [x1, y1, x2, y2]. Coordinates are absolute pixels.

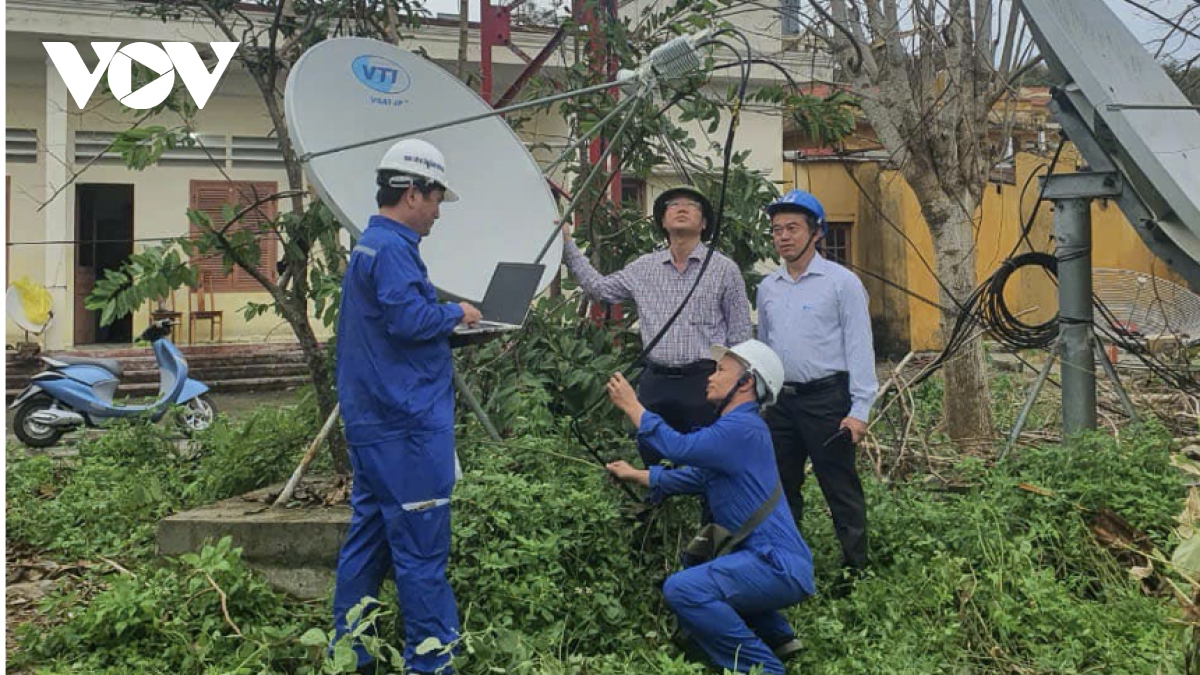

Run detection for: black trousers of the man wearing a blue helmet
[[764, 374, 866, 569]]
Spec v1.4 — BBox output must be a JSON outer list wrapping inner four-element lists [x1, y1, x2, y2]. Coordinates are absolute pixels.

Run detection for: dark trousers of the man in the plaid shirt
[[637, 360, 716, 468]]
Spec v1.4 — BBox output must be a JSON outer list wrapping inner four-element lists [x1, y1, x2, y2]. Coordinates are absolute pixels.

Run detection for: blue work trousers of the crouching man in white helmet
[[662, 550, 805, 675]]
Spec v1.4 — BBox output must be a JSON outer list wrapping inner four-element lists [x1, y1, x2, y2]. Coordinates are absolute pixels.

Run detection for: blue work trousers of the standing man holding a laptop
[[334, 429, 458, 674]]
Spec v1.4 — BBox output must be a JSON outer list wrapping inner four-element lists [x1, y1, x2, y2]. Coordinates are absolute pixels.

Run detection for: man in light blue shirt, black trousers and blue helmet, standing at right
[[758, 190, 876, 583]]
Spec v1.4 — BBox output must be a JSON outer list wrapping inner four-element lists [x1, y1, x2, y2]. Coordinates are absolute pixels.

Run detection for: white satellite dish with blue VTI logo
[[283, 37, 563, 301]]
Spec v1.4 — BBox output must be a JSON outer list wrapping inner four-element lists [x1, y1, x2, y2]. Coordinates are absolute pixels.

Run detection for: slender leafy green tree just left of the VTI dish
[[88, 0, 421, 474]]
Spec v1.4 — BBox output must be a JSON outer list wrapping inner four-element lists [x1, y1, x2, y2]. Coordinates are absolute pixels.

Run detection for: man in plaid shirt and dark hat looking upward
[[563, 186, 751, 467]]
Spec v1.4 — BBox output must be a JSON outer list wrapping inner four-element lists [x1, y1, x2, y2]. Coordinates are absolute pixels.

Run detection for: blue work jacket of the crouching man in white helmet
[[637, 402, 815, 595]]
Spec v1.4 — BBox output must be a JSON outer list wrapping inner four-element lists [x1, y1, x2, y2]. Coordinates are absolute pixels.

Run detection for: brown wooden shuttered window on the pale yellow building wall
[[188, 180, 278, 293]]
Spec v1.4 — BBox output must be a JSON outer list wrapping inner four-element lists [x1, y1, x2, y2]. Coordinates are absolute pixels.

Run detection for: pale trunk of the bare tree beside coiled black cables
[[918, 190, 992, 449]]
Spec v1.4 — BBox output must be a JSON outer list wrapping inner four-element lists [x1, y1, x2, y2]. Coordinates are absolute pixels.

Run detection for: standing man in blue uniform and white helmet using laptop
[[334, 139, 480, 673]]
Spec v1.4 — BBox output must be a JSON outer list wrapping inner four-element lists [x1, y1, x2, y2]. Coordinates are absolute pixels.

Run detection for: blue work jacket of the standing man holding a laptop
[[337, 215, 462, 444]]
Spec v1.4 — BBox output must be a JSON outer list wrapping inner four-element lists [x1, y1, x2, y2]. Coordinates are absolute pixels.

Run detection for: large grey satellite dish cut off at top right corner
[[1021, 0, 1200, 289]]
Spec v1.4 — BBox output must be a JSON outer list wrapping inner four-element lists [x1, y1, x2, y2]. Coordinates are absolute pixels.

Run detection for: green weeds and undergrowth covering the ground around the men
[[7, 399, 1186, 675]]
